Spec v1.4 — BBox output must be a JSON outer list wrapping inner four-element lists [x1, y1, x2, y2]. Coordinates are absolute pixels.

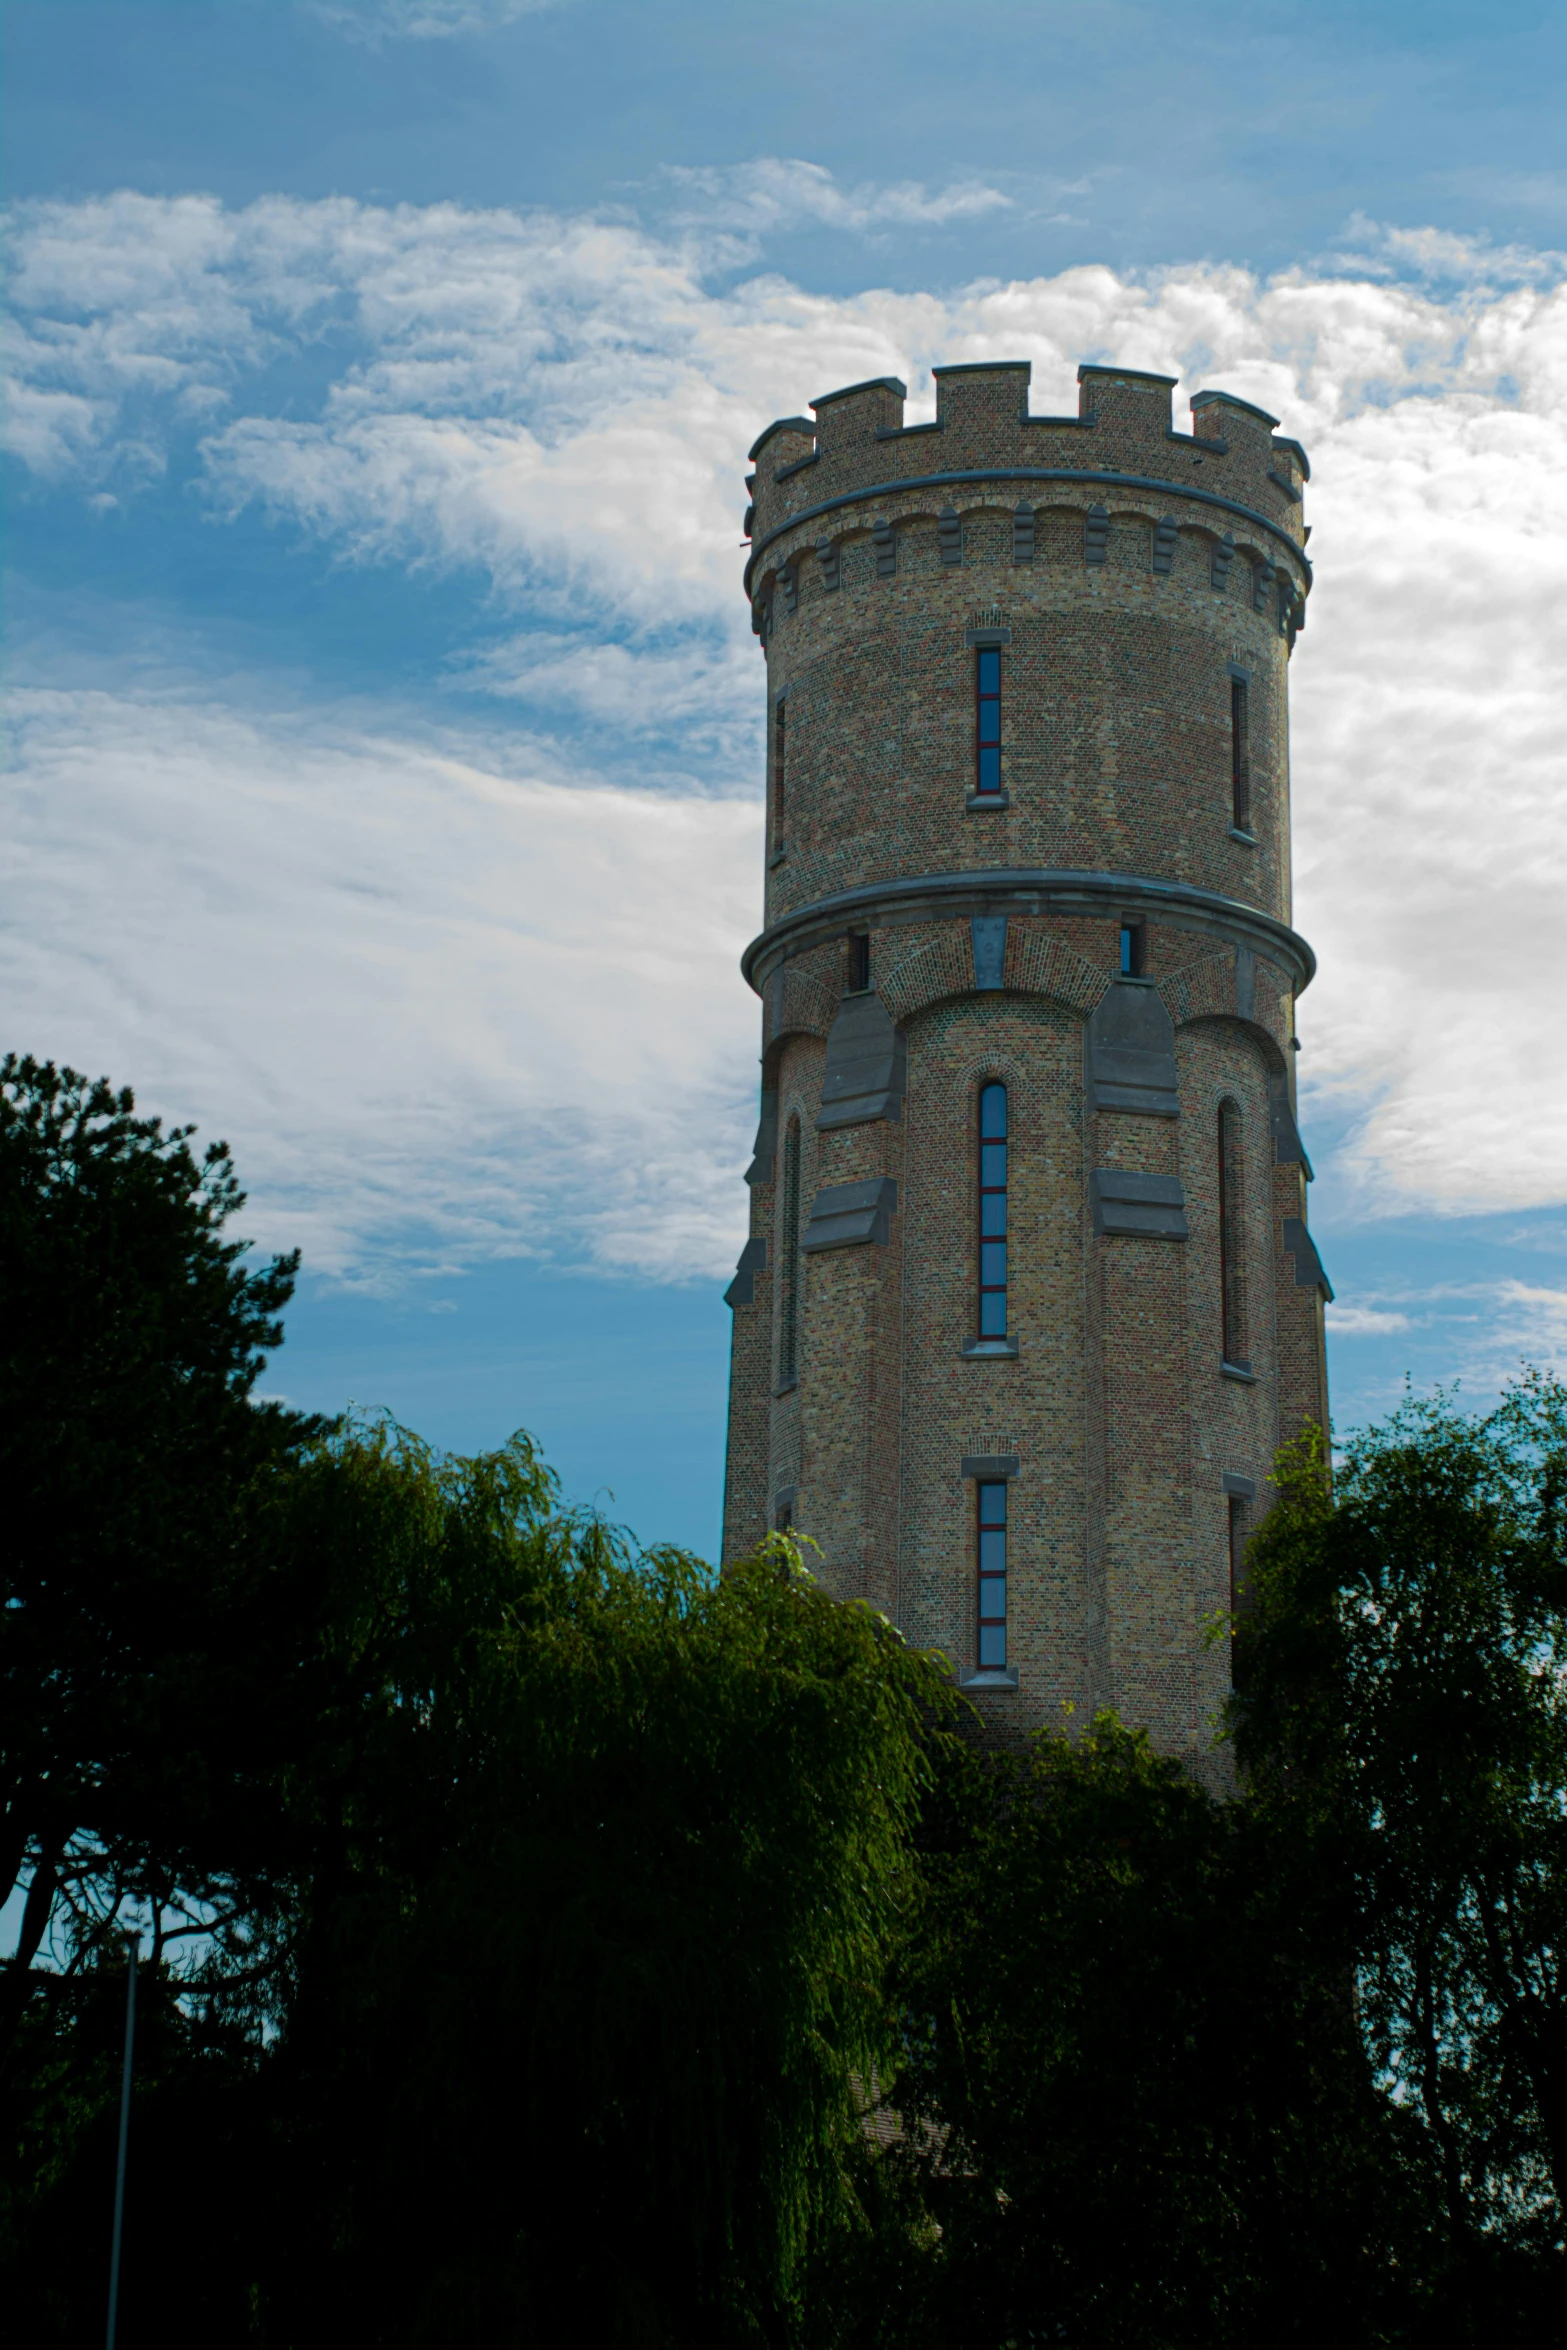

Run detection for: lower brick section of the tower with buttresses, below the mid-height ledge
[[724, 874, 1330, 1753]]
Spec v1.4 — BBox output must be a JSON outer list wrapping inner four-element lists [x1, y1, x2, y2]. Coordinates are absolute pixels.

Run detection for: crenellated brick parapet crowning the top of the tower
[[747, 360, 1311, 569]]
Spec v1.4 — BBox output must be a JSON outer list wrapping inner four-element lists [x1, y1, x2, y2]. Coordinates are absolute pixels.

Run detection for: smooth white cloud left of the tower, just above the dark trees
[[0, 691, 761, 1278]]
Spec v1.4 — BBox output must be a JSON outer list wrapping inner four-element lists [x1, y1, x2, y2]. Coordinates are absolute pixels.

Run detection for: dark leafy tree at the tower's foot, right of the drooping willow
[[855, 1716, 1400, 2350]]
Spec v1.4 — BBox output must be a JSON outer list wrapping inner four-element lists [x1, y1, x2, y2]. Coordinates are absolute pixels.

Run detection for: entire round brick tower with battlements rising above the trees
[[724, 364, 1330, 1753]]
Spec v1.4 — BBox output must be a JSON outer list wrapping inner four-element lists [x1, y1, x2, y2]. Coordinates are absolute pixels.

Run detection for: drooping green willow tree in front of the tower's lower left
[[256, 1426, 944, 2343]]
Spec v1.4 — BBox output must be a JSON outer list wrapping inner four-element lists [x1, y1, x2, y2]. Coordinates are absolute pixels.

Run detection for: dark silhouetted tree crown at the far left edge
[[0, 1055, 315, 2077]]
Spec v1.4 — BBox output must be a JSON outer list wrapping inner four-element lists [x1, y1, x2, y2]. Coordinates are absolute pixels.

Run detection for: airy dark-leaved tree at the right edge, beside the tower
[[1236, 1372, 1567, 2327]]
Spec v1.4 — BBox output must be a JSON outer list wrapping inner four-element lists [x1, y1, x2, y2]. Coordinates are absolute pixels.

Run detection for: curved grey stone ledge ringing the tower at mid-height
[[740, 865, 1316, 994]]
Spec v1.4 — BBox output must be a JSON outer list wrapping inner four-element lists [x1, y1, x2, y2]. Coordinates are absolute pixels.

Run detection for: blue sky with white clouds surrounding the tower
[[0, 0, 1567, 1556]]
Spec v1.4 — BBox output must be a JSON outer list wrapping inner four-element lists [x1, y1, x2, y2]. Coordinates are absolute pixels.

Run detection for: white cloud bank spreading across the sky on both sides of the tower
[[5, 178, 1567, 1274]]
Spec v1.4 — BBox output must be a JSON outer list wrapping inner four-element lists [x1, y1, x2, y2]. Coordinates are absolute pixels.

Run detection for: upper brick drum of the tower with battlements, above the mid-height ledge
[[745, 362, 1311, 926]]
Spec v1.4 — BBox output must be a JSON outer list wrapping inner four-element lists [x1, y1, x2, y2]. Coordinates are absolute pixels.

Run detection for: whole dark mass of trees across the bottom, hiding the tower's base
[[0, 1058, 1567, 2350]]
